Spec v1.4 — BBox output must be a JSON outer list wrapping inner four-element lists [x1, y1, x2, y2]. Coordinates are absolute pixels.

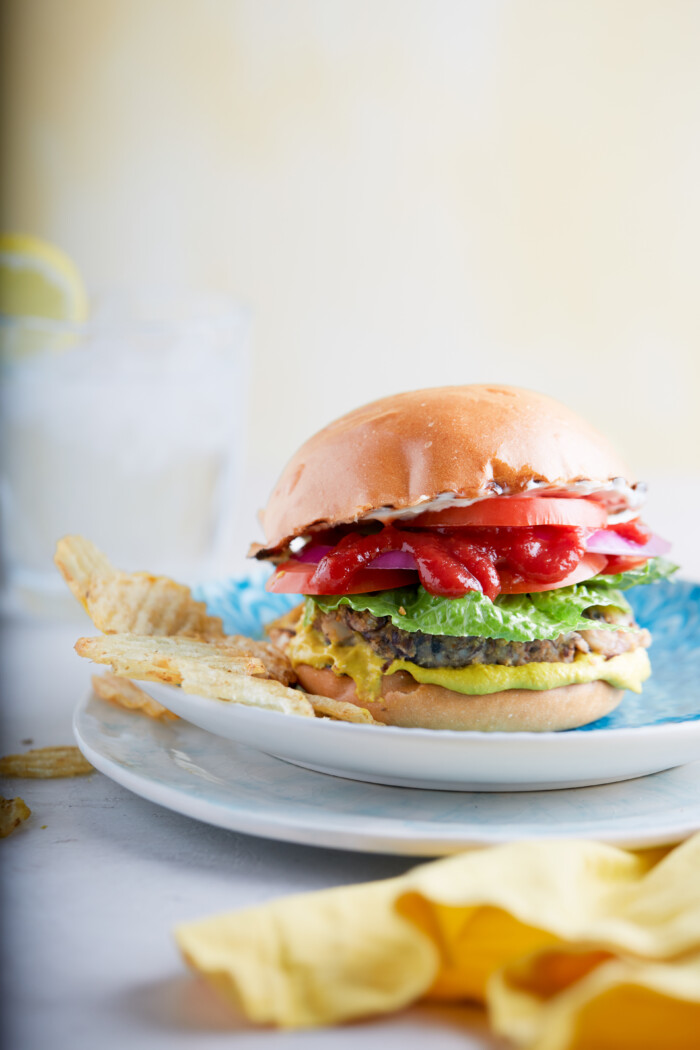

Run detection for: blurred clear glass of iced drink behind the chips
[[0, 293, 250, 613]]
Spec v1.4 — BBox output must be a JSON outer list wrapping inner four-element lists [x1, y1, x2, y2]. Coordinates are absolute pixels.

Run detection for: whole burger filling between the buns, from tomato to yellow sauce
[[261, 498, 675, 701]]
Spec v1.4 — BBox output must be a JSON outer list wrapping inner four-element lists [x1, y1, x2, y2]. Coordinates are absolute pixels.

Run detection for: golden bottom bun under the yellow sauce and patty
[[294, 664, 623, 733]]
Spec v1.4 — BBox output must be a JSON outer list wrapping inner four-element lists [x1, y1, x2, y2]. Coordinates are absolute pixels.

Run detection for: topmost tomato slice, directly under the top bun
[[411, 496, 608, 528]]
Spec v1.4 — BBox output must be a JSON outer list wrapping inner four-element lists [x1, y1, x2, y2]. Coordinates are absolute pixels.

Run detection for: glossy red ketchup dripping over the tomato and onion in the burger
[[312, 525, 586, 601]]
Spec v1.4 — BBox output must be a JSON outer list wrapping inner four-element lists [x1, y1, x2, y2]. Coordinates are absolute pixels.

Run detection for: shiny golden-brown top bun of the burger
[[251, 384, 631, 557]]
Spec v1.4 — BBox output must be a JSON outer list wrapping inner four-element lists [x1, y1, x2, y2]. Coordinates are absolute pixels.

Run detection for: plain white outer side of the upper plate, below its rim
[[125, 683, 700, 792]]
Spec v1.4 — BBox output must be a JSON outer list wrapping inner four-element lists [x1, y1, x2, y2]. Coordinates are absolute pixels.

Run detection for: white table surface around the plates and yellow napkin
[[0, 480, 700, 1050]]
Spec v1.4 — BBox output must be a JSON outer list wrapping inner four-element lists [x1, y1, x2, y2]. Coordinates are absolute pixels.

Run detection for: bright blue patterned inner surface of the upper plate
[[196, 566, 700, 733]]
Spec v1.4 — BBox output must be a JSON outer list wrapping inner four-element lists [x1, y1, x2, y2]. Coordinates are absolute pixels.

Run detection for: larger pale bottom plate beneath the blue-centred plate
[[75, 698, 700, 857]]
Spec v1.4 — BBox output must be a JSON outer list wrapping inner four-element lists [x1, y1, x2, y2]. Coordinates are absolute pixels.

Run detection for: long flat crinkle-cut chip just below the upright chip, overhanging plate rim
[[76, 634, 267, 686]]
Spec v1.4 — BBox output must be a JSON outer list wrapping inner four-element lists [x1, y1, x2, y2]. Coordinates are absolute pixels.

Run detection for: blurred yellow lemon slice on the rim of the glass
[[0, 233, 87, 321]]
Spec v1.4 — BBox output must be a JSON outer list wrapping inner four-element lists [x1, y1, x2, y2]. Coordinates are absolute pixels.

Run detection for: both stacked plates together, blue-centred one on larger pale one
[[75, 579, 700, 856]]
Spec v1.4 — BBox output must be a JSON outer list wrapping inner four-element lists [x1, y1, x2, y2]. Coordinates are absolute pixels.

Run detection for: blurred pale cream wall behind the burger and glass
[[0, 0, 700, 592]]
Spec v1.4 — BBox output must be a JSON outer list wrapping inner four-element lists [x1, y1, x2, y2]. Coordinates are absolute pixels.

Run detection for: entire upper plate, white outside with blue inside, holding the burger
[[119, 580, 700, 792]]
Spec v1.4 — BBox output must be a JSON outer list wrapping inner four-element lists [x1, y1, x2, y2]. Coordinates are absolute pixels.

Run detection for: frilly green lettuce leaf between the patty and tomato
[[305, 559, 677, 642]]
